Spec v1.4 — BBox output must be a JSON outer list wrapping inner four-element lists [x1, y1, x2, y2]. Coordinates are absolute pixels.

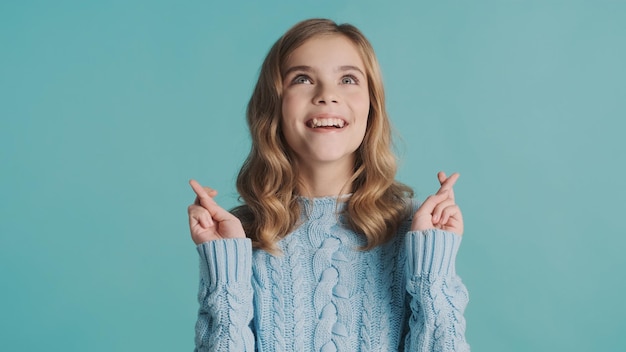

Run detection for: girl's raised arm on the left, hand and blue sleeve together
[[188, 180, 254, 351]]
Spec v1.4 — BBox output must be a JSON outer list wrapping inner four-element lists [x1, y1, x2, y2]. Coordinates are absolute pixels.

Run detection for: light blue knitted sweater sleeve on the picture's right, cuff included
[[405, 229, 470, 352]]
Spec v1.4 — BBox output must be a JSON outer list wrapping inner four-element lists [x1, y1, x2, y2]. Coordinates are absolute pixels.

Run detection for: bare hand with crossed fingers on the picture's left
[[187, 180, 246, 245]]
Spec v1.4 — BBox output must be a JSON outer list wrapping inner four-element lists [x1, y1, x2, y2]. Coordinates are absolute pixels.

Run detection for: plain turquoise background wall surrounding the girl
[[0, 0, 626, 352]]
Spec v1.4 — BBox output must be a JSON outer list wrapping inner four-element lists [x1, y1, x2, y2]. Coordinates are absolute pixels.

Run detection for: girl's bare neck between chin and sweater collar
[[300, 160, 353, 198]]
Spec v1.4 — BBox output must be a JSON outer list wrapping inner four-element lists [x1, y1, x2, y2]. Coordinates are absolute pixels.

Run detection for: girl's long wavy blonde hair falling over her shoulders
[[233, 19, 413, 253]]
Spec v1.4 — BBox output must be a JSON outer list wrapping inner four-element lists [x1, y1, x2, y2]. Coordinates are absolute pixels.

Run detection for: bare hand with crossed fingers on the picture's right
[[411, 172, 463, 236]]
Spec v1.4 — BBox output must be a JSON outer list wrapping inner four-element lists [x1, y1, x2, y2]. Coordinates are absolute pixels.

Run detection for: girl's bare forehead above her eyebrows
[[283, 34, 365, 72]]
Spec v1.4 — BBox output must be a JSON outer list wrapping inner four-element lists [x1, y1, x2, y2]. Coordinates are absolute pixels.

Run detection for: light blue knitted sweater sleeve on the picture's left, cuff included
[[195, 238, 254, 352]]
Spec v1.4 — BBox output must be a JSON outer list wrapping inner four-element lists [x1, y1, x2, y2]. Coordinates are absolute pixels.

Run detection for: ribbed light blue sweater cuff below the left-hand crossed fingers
[[197, 238, 252, 287]]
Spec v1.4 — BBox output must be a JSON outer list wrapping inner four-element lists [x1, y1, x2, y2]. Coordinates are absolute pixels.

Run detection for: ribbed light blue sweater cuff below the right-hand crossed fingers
[[406, 229, 461, 277]]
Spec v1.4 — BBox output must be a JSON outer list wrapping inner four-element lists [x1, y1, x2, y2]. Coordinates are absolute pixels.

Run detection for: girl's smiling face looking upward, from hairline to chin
[[281, 35, 370, 172]]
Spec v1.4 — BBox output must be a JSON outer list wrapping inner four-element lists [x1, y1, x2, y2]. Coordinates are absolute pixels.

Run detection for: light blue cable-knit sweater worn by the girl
[[195, 197, 469, 352]]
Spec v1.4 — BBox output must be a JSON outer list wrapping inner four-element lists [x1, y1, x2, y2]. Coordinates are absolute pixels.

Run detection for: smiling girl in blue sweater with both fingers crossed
[[188, 19, 469, 352]]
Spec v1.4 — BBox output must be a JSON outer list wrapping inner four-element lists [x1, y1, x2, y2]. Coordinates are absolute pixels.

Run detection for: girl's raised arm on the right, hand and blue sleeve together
[[405, 172, 470, 352]]
